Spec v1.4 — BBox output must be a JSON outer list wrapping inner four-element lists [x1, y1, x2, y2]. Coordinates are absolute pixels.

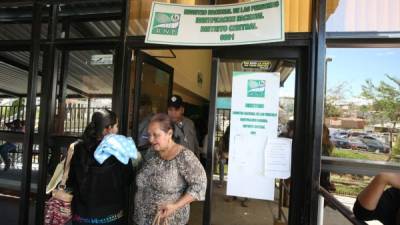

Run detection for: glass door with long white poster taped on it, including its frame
[[203, 47, 306, 225]]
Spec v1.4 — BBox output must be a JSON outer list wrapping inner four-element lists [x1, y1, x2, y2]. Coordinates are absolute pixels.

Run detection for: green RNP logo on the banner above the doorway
[[151, 12, 181, 36]]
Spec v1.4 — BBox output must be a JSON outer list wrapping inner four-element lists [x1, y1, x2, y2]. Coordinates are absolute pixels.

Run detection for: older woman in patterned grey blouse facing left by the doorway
[[134, 113, 207, 225]]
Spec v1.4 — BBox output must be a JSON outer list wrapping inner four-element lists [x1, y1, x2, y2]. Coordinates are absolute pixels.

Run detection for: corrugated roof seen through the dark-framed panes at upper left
[[0, 1, 120, 95]]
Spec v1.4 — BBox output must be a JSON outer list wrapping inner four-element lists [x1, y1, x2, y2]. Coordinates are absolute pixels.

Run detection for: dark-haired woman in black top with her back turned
[[67, 109, 133, 225]]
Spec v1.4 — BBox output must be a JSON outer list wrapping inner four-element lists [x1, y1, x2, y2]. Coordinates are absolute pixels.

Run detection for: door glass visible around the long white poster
[[212, 59, 296, 225]]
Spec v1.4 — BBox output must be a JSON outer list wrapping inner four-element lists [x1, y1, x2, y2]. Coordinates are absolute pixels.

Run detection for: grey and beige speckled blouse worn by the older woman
[[134, 147, 207, 225]]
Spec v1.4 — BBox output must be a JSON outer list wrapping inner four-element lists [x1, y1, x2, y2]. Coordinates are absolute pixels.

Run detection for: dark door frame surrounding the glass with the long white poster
[[203, 44, 315, 225]]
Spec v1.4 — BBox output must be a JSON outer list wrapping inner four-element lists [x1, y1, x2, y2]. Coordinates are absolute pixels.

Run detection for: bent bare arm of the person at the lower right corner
[[357, 173, 400, 211]]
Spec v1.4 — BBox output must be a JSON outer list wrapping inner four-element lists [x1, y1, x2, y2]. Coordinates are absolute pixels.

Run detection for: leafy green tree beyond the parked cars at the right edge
[[361, 74, 400, 153]]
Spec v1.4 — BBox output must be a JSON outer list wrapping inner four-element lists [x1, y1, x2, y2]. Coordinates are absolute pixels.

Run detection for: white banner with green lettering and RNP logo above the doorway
[[145, 0, 285, 46]]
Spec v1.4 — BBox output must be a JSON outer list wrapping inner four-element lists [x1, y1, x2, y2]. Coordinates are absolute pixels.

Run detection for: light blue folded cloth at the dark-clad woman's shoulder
[[94, 134, 138, 165]]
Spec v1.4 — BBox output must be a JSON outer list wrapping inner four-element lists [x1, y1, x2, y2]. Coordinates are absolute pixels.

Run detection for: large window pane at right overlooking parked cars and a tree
[[325, 48, 400, 161]]
